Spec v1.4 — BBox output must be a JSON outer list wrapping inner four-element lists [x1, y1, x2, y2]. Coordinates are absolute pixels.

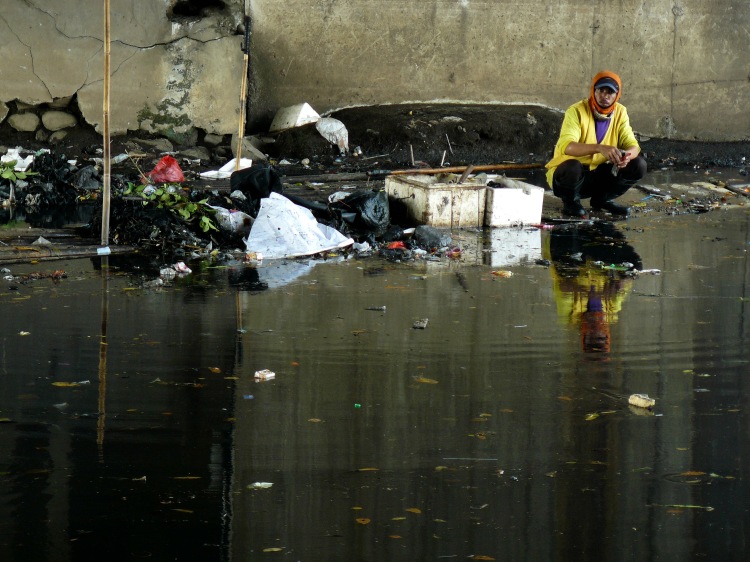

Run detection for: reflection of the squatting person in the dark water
[[545, 222, 642, 352]]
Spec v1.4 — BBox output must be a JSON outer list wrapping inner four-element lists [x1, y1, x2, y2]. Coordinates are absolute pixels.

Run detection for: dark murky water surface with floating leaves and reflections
[[0, 186, 750, 562]]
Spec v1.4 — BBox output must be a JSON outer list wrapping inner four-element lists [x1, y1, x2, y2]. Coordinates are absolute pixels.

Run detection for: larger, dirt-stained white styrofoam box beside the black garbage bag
[[385, 174, 487, 228]]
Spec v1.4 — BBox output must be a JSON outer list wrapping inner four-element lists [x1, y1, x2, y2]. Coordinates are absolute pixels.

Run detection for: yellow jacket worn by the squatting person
[[546, 99, 640, 187]]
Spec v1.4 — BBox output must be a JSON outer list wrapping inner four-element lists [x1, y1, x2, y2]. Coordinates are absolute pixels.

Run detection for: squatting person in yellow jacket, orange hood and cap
[[547, 71, 646, 218]]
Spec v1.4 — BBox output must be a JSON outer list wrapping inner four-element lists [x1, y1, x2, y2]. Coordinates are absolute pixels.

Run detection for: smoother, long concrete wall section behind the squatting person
[[251, 0, 750, 140]]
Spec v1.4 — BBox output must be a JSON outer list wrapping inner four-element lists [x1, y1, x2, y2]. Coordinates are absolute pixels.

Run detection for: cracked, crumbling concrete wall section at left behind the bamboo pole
[[0, 0, 244, 135]]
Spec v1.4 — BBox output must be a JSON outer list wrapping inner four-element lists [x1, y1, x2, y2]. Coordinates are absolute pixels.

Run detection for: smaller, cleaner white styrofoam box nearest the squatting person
[[484, 178, 544, 227]]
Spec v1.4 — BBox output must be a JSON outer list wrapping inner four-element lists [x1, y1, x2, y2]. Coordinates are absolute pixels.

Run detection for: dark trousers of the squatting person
[[552, 154, 646, 204]]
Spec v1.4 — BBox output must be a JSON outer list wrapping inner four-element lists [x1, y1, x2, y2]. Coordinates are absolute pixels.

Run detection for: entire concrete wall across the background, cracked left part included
[[0, 0, 750, 140]]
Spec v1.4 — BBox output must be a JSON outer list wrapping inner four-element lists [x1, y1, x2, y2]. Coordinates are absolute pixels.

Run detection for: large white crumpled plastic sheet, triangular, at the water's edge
[[245, 193, 354, 259]]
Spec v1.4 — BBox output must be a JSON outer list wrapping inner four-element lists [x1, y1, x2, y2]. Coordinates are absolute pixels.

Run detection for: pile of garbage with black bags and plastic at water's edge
[[0, 142, 462, 261]]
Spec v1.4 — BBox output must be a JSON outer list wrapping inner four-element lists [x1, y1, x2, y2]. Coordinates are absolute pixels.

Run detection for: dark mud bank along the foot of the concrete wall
[[0, 104, 750, 173]]
